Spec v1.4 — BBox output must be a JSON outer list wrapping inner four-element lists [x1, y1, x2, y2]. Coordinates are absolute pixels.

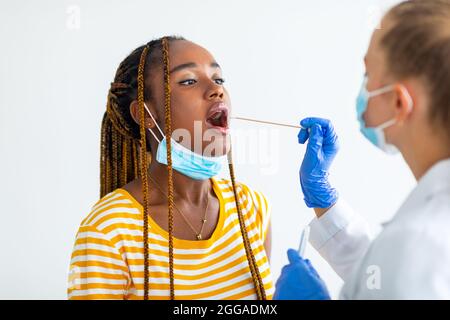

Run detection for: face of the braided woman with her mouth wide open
[[145, 40, 231, 156]]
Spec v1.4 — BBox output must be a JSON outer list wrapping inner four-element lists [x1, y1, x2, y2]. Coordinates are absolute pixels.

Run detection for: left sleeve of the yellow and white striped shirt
[[67, 225, 130, 300]]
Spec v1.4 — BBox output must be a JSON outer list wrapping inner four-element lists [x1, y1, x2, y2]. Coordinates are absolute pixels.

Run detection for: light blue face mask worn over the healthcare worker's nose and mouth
[[356, 76, 413, 154]]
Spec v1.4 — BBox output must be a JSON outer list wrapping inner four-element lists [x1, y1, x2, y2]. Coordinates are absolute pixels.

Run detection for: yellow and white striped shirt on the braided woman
[[67, 178, 274, 299]]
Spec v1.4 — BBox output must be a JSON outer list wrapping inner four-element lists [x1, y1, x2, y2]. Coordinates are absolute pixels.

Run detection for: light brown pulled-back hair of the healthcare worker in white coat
[[381, 0, 450, 141]]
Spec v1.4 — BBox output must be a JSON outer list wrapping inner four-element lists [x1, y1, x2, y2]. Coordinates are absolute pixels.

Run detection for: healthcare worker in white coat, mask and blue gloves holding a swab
[[274, 0, 450, 299]]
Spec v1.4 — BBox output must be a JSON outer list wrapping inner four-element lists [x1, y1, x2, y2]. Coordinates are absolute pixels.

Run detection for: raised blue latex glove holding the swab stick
[[298, 118, 339, 208]]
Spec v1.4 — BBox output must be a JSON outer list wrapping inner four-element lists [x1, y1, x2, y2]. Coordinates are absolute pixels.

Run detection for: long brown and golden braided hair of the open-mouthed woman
[[100, 36, 266, 300]]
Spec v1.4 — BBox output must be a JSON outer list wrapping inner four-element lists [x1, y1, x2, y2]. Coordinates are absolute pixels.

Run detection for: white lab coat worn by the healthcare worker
[[310, 159, 450, 299]]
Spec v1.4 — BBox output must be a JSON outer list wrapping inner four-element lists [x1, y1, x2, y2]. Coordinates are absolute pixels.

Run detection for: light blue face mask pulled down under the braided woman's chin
[[144, 103, 226, 180]]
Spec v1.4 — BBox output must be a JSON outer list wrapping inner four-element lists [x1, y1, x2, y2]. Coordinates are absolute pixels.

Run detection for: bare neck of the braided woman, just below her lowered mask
[[148, 161, 211, 204]]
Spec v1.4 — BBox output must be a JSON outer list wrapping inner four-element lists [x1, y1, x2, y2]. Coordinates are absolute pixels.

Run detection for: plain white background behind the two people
[[0, 0, 415, 299]]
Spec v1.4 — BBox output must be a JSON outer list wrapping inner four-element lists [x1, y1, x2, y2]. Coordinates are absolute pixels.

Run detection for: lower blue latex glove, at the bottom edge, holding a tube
[[273, 249, 330, 300]]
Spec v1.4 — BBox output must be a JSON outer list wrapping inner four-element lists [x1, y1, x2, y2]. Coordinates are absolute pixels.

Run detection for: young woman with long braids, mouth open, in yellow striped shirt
[[68, 37, 274, 299]]
